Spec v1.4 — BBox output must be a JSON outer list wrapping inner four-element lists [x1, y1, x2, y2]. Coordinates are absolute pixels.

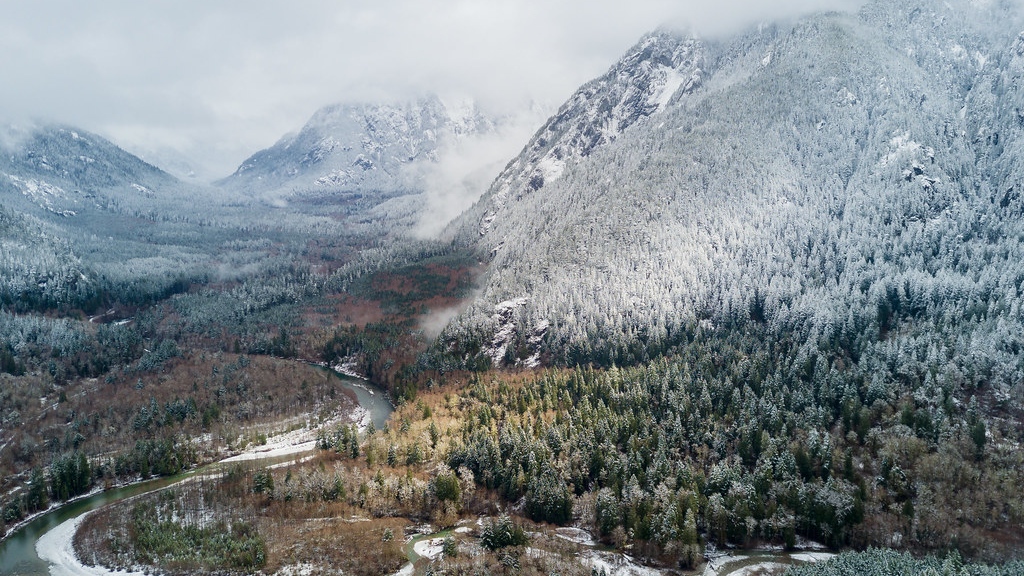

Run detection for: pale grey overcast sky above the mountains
[[0, 0, 856, 177]]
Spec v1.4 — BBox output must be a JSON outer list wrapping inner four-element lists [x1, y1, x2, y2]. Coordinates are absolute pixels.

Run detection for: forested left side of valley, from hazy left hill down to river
[[0, 118, 469, 532]]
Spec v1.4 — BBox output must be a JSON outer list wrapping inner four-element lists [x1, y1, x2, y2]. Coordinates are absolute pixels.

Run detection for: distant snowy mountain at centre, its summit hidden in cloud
[[218, 95, 496, 226]]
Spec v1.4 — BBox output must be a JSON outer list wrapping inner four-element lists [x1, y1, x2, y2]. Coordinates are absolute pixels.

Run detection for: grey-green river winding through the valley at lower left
[[0, 371, 394, 576]]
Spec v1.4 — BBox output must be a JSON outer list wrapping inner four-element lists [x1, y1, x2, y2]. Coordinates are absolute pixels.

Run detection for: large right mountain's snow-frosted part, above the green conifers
[[440, 0, 1024, 399]]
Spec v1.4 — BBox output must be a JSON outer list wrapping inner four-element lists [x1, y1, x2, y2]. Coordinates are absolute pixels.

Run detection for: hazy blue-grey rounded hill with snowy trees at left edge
[[0, 125, 255, 310]]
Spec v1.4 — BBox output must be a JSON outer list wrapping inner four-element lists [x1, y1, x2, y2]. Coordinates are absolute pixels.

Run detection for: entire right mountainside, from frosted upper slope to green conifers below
[[423, 1, 1024, 560]]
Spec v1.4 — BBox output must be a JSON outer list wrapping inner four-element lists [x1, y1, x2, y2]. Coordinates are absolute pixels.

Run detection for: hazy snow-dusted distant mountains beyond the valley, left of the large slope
[[0, 96, 520, 301]]
